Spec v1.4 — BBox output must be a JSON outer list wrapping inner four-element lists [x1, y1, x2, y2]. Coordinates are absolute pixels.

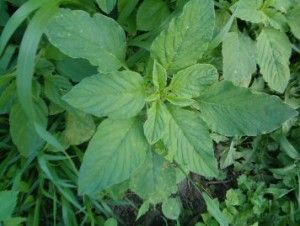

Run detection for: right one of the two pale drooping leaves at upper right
[[257, 28, 292, 93]]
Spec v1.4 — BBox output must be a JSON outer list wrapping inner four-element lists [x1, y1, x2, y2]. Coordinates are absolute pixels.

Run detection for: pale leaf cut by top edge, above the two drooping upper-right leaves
[[231, 0, 267, 23]]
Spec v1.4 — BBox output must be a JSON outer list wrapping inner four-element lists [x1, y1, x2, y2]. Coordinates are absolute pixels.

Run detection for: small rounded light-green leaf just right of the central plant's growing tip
[[170, 64, 218, 98]]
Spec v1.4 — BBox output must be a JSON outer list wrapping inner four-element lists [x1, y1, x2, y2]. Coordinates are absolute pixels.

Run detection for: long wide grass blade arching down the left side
[[17, 0, 63, 150]]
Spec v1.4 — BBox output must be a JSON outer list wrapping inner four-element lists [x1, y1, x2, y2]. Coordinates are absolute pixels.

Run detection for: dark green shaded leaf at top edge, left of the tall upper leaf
[[136, 0, 170, 31]]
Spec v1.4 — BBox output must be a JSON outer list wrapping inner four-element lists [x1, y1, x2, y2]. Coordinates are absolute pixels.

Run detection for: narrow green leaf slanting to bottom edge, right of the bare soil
[[202, 193, 229, 226]]
